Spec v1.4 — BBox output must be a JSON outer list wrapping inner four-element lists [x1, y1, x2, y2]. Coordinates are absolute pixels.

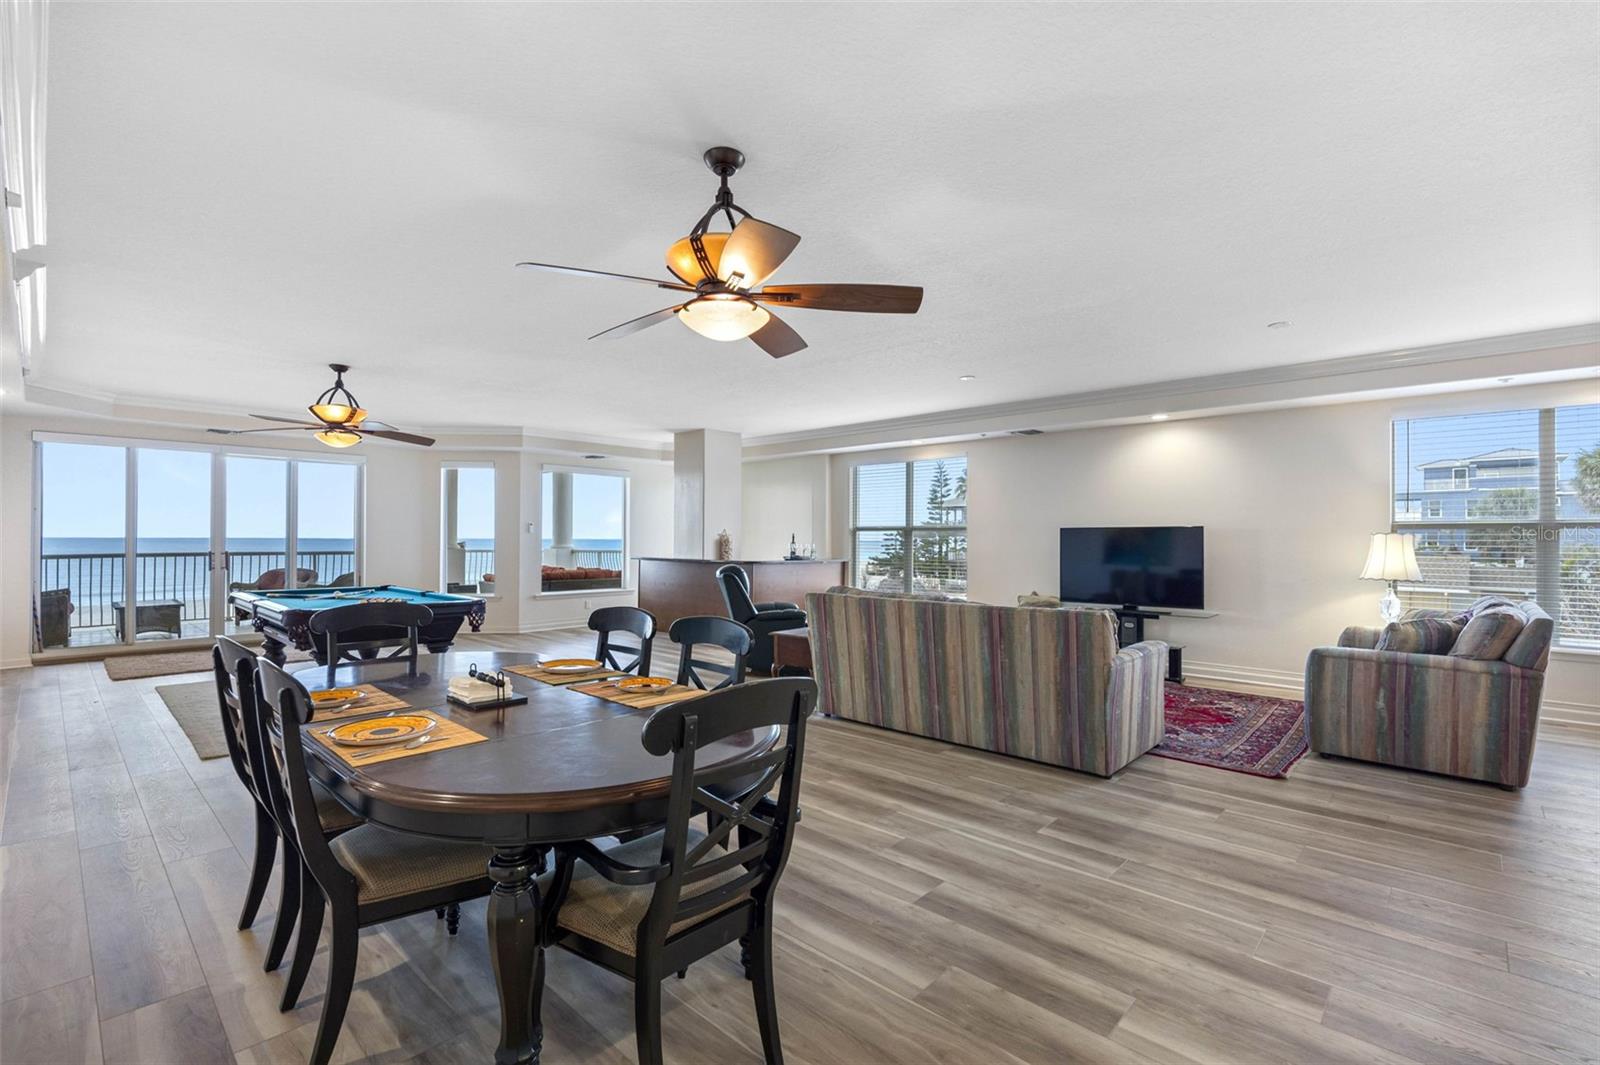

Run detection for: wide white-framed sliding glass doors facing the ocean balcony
[[34, 433, 362, 651]]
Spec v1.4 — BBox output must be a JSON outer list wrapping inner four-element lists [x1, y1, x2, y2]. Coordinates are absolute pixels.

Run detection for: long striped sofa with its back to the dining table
[[806, 588, 1166, 777]]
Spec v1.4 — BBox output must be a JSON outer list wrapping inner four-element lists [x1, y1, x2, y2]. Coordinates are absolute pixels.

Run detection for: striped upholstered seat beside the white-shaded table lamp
[[1306, 600, 1554, 788]]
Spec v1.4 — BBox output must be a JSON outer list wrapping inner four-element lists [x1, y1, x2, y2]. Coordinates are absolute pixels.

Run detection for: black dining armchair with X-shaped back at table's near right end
[[544, 678, 816, 1065]]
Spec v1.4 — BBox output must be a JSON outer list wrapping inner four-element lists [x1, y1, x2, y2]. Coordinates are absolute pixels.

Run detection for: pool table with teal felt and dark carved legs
[[227, 584, 485, 665]]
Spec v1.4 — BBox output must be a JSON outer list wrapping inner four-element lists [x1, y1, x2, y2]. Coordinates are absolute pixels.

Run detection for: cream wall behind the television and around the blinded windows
[[812, 381, 1600, 720]]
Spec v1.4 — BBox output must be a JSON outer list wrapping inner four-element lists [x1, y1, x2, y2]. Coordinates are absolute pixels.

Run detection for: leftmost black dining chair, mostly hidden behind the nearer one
[[211, 636, 362, 972]]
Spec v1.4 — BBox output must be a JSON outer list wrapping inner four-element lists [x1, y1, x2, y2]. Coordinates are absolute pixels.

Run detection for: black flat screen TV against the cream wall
[[1061, 525, 1205, 611]]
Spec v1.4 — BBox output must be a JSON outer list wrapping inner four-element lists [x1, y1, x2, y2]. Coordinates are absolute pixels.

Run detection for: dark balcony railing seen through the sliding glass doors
[[38, 552, 355, 628]]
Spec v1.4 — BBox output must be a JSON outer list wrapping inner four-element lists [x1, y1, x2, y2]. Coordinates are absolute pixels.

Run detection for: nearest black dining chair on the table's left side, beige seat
[[256, 659, 494, 1065]]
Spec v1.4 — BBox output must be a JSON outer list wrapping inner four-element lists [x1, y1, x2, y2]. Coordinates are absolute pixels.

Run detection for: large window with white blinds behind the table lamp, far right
[[1394, 403, 1600, 649]]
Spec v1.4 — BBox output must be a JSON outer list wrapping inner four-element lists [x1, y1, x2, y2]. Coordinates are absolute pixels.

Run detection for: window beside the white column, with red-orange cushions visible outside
[[539, 467, 627, 592]]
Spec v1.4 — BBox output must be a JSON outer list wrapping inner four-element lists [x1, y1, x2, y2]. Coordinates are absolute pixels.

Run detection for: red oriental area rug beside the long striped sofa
[[1150, 684, 1306, 777]]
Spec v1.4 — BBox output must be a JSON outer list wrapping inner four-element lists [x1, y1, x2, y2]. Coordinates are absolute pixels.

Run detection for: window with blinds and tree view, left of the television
[[850, 454, 966, 596]]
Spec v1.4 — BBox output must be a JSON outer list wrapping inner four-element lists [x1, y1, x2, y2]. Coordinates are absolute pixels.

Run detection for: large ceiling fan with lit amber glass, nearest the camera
[[517, 147, 922, 358]]
